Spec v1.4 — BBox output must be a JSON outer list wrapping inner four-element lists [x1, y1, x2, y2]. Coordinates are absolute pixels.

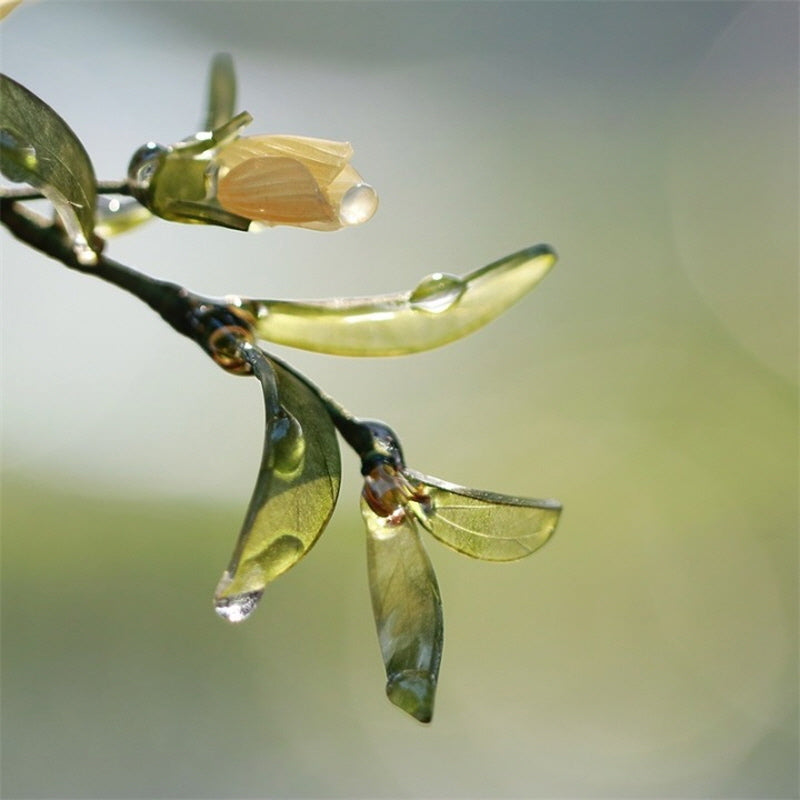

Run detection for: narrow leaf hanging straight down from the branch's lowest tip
[[361, 499, 444, 722]]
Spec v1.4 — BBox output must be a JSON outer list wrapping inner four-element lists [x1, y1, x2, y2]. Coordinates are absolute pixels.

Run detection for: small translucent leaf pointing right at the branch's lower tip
[[404, 468, 561, 561]]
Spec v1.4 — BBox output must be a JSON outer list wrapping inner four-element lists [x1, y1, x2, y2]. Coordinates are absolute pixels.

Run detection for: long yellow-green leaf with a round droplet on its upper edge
[[240, 244, 556, 356]]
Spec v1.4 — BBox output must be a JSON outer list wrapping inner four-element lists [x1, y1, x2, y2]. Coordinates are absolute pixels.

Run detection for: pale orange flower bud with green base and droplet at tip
[[128, 112, 378, 231]]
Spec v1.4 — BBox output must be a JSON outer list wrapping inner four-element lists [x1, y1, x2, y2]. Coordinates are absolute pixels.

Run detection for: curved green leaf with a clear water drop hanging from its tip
[[214, 345, 341, 622]]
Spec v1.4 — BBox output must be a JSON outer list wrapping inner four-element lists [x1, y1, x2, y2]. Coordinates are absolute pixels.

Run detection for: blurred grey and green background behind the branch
[[0, 2, 798, 798]]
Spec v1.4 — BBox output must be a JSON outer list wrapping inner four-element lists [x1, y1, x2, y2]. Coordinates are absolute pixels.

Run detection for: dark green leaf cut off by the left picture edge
[[0, 75, 96, 263]]
